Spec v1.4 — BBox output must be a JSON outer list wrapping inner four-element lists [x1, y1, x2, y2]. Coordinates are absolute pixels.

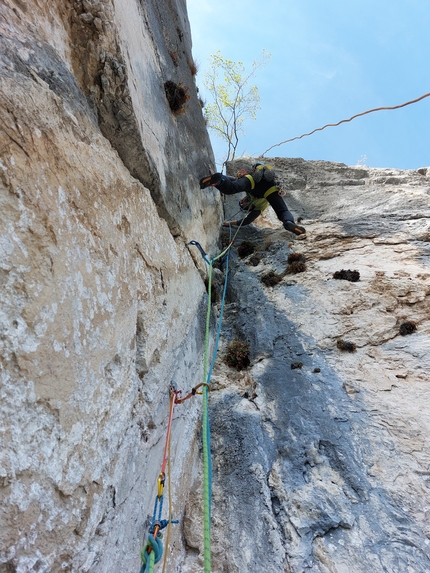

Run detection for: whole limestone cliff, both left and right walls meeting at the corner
[[0, 0, 430, 573]]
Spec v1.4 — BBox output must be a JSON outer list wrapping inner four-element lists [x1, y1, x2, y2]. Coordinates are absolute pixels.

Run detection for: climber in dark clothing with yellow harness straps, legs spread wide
[[200, 163, 306, 235]]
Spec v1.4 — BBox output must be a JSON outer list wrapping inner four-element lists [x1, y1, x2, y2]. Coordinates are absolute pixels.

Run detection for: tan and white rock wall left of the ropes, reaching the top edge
[[0, 0, 221, 573]]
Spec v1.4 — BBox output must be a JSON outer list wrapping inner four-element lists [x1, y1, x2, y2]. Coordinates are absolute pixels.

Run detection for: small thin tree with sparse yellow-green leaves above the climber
[[204, 50, 271, 167]]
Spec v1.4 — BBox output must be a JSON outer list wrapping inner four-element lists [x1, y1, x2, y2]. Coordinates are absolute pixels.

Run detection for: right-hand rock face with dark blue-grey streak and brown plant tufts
[[191, 159, 430, 573]]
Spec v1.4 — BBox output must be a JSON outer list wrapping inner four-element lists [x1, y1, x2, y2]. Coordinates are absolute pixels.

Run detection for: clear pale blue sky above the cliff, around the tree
[[187, 0, 430, 169]]
